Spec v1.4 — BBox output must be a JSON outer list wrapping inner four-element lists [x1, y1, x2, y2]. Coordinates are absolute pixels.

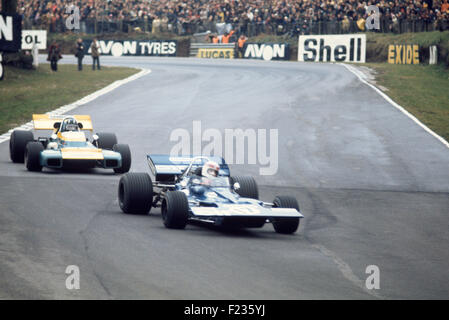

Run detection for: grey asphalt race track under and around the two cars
[[0, 57, 449, 299]]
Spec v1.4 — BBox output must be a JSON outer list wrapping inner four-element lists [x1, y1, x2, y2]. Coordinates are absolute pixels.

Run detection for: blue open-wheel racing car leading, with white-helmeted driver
[[118, 155, 303, 234]]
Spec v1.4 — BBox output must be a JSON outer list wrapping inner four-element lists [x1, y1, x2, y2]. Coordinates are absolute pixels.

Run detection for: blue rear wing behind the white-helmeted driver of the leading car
[[147, 154, 229, 182]]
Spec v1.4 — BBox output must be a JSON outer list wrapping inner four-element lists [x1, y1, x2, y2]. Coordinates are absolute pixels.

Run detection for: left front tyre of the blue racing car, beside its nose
[[161, 191, 189, 229]]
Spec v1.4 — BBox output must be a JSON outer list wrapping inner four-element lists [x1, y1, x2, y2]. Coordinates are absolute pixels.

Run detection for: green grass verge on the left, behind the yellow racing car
[[0, 64, 138, 134]]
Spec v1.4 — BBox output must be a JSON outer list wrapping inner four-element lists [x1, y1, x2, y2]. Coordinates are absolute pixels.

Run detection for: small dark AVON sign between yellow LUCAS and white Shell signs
[[243, 43, 290, 61]]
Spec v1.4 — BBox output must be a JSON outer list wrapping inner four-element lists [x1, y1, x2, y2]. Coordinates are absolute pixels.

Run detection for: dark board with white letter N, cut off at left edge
[[0, 13, 22, 52]]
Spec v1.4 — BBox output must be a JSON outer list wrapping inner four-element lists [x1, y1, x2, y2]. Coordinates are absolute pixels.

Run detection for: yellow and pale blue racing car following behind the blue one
[[9, 114, 131, 173]]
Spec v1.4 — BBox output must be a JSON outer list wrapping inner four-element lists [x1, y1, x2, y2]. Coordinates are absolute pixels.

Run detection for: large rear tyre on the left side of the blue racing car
[[118, 172, 153, 214]]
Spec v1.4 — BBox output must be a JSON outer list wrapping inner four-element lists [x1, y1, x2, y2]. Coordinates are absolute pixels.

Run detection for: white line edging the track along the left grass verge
[[0, 69, 151, 143]]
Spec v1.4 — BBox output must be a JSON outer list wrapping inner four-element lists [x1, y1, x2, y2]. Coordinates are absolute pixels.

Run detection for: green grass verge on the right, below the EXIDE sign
[[366, 63, 449, 141]]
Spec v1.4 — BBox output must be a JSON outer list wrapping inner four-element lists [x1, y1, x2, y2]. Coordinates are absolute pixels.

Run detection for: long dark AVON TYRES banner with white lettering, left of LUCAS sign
[[84, 40, 177, 57]]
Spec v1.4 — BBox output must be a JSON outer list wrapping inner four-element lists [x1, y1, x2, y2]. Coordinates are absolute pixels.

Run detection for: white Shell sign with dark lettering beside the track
[[298, 34, 366, 63]]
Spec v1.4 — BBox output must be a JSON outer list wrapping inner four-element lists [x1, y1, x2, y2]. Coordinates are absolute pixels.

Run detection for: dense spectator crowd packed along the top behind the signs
[[3, 0, 449, 36]]
